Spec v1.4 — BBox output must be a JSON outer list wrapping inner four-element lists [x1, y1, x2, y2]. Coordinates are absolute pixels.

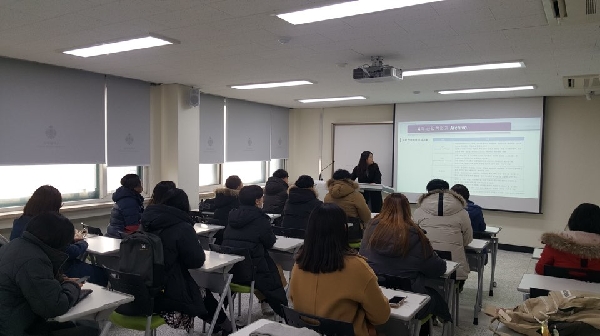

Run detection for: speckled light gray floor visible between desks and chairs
[[109, 251, 535, 336]]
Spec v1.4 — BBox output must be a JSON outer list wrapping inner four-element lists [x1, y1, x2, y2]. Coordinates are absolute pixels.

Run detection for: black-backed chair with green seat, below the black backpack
[[101, 270, 166, 336]]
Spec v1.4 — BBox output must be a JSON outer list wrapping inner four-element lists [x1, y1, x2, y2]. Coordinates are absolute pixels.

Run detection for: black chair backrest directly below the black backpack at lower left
[[108, 269, 158, 316]]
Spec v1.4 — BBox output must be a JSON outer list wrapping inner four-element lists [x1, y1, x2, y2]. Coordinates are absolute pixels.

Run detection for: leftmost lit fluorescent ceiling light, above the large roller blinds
[[63, 36, 175, 57]]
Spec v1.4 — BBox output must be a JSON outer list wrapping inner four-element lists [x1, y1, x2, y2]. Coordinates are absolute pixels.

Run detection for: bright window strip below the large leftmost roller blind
[[0, 164, 99, 206]]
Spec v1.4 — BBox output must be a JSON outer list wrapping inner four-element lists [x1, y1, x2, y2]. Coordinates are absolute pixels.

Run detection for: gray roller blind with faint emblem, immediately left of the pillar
[[106, 76, 150, 167]]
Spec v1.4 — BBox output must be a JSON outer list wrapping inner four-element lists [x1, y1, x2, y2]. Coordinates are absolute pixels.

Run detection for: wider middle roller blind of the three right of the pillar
[[225, 99, 271, 161]]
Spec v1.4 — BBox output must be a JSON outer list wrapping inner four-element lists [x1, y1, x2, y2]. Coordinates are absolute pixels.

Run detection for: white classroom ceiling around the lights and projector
[[0, 0, 600, 107]]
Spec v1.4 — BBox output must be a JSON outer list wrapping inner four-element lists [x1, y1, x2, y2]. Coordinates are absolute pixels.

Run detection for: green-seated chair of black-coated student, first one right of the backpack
[[210, 244, 256, 324]]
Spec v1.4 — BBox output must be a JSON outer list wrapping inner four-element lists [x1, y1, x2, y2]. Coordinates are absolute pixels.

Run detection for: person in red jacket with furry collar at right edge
[[535, 203, 600, 275]]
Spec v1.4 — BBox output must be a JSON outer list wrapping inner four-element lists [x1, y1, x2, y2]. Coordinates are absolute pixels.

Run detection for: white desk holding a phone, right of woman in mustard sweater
[[379, 287, 430, 335]]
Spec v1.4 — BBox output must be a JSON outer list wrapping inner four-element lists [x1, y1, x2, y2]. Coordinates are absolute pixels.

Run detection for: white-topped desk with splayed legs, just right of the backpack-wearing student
[[189, 251, 244, 336]]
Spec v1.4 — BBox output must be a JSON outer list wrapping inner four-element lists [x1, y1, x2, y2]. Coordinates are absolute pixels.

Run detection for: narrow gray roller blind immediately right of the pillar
[[200, 94, 225, 163]]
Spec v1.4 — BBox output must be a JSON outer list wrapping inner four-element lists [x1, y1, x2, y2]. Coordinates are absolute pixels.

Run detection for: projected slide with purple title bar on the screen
[[396, 98, 543, 212]]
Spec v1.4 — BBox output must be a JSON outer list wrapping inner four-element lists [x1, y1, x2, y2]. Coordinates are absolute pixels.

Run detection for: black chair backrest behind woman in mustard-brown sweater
[[282, 305, 354, 336]]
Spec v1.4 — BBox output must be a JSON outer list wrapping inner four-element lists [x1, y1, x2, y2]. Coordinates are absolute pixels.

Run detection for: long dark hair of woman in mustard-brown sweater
[[296, 203, 356, 274]]
